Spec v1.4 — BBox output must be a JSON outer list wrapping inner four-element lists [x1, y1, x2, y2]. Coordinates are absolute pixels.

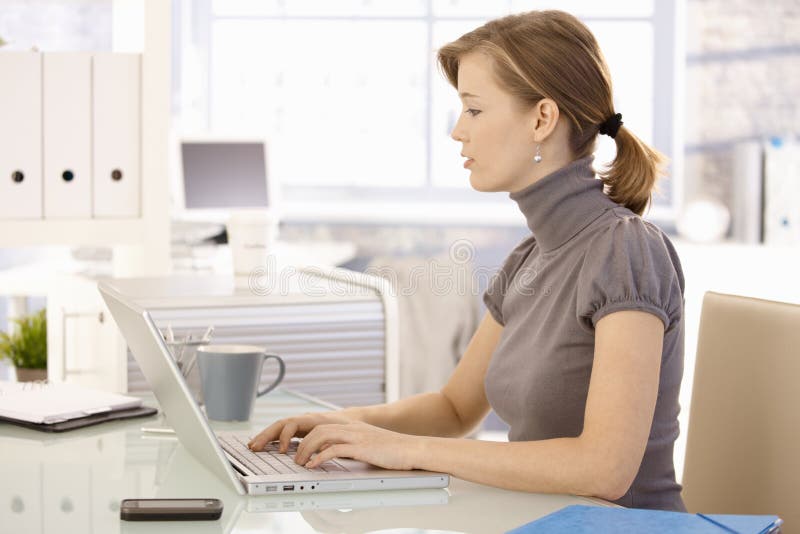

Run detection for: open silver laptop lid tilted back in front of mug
[[98, 282, 246, 495]]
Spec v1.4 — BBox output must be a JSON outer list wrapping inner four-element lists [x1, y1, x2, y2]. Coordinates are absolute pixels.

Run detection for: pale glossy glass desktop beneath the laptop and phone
[[0, 389, 611, 534]]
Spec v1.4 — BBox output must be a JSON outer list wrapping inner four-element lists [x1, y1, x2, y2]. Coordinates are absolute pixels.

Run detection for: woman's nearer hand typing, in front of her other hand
[[294, 421, 425, 470]]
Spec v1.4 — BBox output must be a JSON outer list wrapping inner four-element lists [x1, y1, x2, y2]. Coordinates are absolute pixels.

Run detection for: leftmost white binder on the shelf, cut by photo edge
[[0, 52, 42, 219]]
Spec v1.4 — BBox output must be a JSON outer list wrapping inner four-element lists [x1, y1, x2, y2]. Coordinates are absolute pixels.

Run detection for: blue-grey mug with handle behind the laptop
[[197, 345, 286, 421]]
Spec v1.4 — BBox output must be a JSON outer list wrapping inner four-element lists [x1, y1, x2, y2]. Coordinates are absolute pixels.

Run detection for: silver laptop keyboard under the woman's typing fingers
[[217, 434, 347, 475]]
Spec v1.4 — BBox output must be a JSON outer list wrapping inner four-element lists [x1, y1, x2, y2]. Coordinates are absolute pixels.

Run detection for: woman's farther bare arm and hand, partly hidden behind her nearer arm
[[249, 313, 503, 450]]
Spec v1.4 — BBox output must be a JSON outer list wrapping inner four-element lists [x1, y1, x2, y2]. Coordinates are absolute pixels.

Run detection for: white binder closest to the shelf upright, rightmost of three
[[92, 53, 141, 218]]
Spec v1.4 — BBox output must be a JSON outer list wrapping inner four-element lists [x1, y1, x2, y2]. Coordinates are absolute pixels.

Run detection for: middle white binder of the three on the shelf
[[42, 52, 92, 219]]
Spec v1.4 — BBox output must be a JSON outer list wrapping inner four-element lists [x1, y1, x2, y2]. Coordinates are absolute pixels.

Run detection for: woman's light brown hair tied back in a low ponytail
[[438, 10, 667, 215]]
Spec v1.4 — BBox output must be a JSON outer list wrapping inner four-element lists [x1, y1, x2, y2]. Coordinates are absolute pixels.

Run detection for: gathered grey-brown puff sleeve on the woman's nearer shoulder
[[577, 215, 684, 331]]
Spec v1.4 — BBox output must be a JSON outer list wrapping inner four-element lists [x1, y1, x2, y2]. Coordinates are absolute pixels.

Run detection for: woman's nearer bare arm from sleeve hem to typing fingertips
[[296, 311, 664, 500]]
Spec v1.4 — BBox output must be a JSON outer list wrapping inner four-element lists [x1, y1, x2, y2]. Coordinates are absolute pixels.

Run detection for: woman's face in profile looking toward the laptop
[[450, 53, 536, 191]]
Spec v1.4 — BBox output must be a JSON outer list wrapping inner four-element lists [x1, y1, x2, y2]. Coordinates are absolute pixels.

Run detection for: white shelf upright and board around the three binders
[[0, 0, 172, 266]]
